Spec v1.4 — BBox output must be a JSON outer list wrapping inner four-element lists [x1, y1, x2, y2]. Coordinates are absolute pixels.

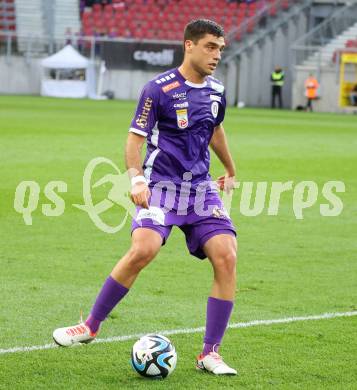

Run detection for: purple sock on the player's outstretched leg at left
[[85, 276, 129, 333]]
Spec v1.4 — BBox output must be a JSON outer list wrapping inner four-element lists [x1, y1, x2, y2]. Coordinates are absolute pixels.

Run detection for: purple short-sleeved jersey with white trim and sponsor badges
[[130, 69, 226, 190]]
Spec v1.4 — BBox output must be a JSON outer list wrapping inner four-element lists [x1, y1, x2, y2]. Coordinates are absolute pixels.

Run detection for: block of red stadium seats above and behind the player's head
[[81, 0, 289, 41]]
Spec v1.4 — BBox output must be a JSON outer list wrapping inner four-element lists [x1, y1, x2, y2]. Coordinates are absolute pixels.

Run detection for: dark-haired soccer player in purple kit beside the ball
[[53, 19, 237, 375]]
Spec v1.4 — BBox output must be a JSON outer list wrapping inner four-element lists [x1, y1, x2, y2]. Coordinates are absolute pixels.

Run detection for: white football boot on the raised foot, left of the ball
[[53, 322, 96, 347]]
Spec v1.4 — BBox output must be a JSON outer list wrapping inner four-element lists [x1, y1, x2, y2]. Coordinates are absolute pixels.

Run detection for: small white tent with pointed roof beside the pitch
[[41, 45, 90, 98]]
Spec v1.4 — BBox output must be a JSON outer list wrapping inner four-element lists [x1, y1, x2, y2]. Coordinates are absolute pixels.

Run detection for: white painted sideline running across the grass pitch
[[0, 310, 357, 355]]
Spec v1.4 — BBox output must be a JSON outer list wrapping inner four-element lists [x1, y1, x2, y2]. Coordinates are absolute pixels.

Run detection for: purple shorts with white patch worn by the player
[[132, 189, 236, 259]]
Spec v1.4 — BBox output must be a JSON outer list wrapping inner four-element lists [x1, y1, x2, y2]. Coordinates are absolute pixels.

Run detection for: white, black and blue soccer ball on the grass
[[131, 334, 177, 378]]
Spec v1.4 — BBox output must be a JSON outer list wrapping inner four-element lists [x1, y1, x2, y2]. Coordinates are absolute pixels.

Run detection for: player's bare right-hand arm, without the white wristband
[[210, 123, 236, 193]]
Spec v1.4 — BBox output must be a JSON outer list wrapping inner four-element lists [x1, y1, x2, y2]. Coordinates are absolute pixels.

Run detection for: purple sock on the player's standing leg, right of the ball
[[202, 297, 233, 355]]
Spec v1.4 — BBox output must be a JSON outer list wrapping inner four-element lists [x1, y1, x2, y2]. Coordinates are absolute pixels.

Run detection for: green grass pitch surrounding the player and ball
[[0, 96, 357, 389]]
